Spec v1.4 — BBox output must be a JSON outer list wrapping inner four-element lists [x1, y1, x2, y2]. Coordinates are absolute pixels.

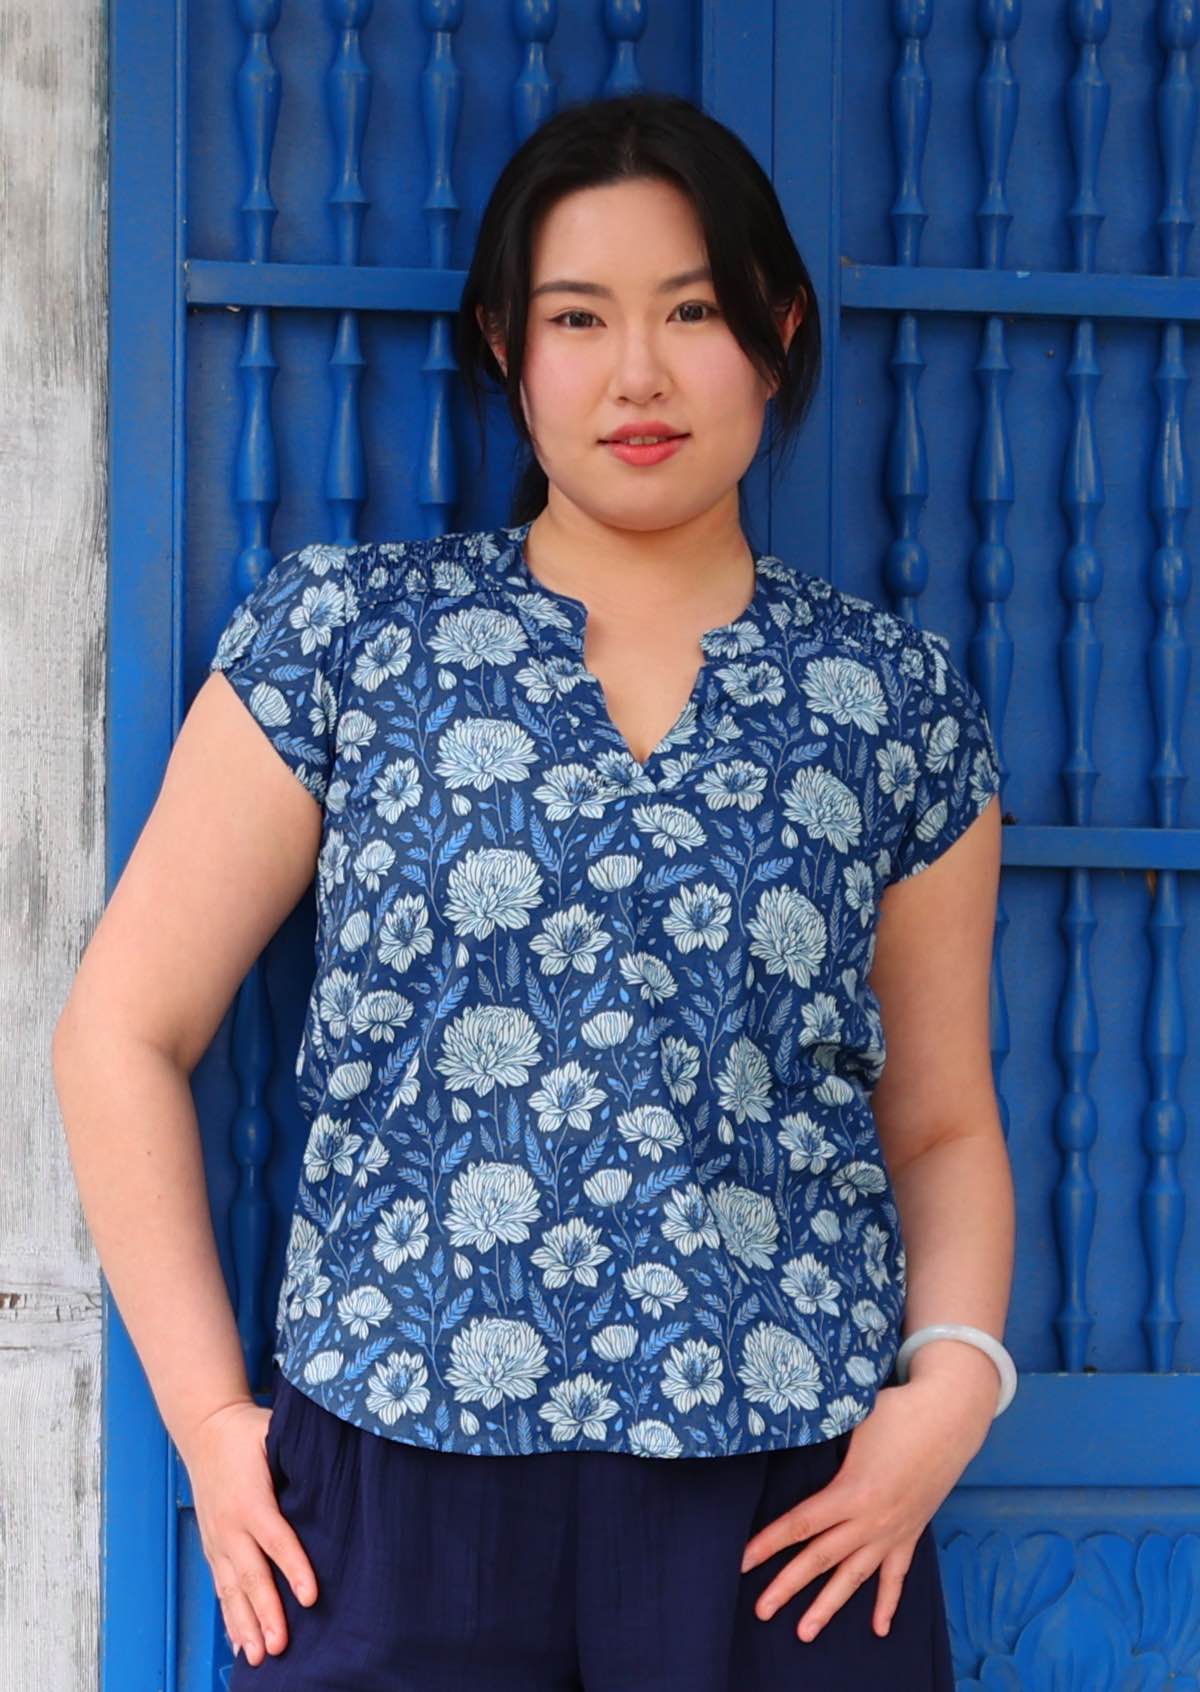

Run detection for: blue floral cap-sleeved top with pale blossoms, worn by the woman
[[210, 523, 999, 1457]]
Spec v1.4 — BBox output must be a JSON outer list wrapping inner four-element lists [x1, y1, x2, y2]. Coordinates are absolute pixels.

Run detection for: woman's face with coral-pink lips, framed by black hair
[[477, 179, 799, 530]]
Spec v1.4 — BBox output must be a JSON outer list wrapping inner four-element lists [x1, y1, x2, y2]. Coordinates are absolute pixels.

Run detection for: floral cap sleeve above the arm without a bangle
[[208, 545, 359, 802]]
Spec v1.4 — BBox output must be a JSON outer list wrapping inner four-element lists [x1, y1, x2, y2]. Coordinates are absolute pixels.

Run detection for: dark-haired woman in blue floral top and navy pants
[[56, 95, 1014, 1692]]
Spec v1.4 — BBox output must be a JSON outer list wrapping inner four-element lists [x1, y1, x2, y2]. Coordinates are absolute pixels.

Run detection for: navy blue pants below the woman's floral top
[[228, 1369, 955, 1692]]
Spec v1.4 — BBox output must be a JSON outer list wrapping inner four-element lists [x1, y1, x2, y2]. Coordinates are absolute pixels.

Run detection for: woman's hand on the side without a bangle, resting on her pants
[[181, 1399, 317, 1663]]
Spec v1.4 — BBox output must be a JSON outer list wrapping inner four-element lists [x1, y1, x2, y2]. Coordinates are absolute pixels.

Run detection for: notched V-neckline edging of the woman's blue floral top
[[501, 518, 773, 790]]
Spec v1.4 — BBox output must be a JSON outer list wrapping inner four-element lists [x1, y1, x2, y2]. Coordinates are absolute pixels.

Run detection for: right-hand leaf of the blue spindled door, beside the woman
[[785, 0, 1200, 1692]]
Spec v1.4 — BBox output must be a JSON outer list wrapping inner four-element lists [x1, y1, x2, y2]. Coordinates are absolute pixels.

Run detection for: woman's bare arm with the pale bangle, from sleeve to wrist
[[870, 799, 1016, 1438]]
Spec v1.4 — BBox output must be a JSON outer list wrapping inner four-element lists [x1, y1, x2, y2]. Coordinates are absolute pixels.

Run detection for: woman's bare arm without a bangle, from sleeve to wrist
[[52, 673, 322, 1460]]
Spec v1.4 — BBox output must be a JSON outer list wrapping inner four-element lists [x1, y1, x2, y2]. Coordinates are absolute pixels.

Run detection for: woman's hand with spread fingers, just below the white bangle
[[741, 1374, 995, 1640]]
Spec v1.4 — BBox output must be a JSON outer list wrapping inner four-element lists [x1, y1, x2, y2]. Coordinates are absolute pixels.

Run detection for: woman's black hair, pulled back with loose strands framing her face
[[454, 90, 821, 525]]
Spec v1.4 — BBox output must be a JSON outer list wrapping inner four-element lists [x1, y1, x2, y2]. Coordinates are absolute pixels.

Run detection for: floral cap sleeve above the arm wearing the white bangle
[[889, 629, 1000, 882]]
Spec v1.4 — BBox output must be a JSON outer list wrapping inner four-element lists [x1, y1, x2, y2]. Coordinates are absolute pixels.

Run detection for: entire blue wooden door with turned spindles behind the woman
[[103, 0, 1200, 1692]]
